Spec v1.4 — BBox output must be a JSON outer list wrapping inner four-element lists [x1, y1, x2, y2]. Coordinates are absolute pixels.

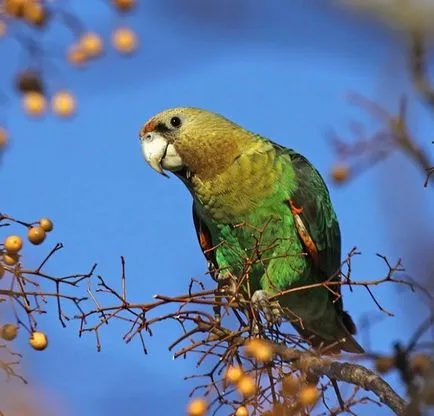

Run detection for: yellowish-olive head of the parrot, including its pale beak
[[139, 107, 249, 178]]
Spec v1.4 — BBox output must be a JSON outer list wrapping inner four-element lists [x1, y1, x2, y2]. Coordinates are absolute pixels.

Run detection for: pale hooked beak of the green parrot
[[140, 132, 183, 177]]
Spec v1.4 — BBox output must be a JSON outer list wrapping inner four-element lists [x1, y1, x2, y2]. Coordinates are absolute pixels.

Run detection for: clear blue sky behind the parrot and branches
[[0, 0, 434, 416]]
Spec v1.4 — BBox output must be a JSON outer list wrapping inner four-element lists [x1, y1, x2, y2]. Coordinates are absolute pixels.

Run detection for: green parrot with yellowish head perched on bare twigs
[[140, 107, 364, 353]]
